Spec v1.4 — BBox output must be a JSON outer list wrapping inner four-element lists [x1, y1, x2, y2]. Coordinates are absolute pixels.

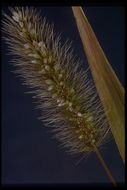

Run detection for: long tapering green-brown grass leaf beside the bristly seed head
[[72, 7, 125, 162]]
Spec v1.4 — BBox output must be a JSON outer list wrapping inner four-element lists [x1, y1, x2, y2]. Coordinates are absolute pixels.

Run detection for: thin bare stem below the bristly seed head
[[93, 145, 117, 187]]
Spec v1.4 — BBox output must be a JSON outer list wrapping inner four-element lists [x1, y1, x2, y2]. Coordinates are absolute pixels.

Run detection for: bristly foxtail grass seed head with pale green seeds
[[3, 7, 110, 156]]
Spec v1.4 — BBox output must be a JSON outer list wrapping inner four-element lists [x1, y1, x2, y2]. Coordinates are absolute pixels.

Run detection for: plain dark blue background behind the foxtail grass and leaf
[[2, 7, 124, 184]]
